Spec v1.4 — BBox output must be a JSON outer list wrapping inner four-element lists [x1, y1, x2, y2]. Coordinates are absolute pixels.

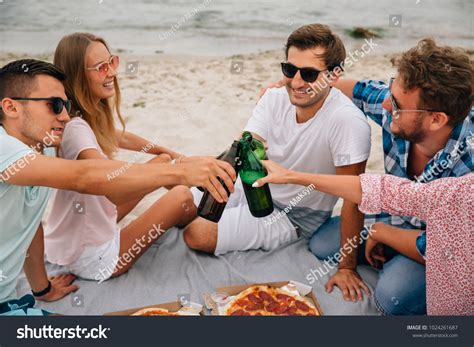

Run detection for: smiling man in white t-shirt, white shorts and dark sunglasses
[[184, 24, 370, 300]]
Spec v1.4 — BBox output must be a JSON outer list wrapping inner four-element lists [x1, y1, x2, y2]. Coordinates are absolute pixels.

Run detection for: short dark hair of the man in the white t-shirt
[[285, 23, 346, 71]]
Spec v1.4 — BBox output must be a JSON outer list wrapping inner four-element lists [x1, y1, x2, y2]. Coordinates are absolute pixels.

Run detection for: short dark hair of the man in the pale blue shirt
[[0, 59, 66, 124]]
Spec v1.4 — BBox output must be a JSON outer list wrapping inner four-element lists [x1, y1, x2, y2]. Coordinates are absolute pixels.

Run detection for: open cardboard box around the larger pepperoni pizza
[[204, 281, 323, 316]]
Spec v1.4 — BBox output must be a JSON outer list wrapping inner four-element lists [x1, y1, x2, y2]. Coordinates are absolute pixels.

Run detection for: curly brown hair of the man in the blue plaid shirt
[[392, 38, 474, 127]]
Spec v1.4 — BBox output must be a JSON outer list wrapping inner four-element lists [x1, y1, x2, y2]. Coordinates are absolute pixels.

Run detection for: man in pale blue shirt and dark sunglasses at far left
[[0, 59, 235, 315]]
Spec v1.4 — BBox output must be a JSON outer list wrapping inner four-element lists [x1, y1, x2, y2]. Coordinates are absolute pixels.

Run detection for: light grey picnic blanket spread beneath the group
[[17, 228, 379, 315]]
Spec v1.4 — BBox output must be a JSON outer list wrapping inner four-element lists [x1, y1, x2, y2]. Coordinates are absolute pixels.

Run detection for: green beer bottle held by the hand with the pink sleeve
[[238, 135, 273, 218]]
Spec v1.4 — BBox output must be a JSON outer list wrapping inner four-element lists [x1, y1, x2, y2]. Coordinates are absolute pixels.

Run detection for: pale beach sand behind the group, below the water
[[0, 51, 395, 225]]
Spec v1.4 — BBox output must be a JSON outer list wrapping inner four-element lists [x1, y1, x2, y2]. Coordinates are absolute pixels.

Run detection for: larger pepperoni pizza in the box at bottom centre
[[224, 285, 319, 316]]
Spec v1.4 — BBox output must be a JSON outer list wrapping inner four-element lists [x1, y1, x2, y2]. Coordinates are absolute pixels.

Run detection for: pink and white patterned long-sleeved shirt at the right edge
[[359, 174, 474, 315]]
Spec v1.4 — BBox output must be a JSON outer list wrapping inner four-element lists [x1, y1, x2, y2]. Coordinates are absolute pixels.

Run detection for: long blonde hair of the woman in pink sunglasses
[[54, 33, 125, 159]]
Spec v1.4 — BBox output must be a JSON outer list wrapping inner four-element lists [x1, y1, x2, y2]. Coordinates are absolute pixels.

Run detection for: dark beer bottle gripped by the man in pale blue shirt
[[198, 141, 239, 223]]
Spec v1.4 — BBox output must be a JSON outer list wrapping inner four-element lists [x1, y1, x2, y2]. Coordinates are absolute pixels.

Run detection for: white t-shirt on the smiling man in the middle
[[245, 87, 370, 237]]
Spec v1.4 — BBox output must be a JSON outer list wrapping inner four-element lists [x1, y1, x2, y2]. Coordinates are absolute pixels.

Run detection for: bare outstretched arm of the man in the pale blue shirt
[[0, 154, 236, 203]]
